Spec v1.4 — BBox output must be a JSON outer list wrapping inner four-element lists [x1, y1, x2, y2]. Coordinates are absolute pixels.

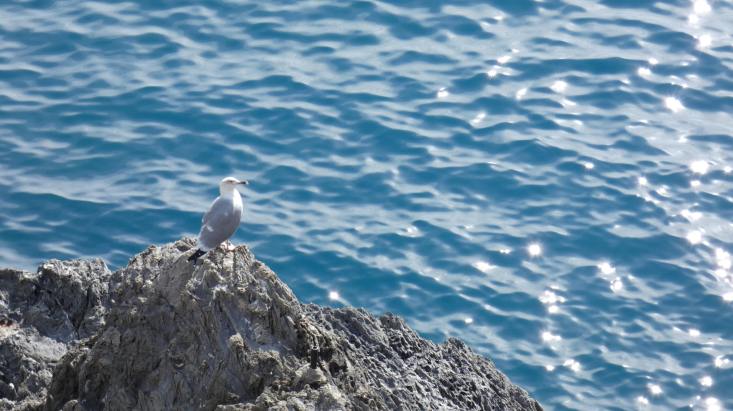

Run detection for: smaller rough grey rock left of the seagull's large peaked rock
[[0, 260, 111, 410]]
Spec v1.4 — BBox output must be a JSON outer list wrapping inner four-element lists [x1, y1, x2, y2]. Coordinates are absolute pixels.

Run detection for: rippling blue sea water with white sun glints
[[0, 0, 733, 411]]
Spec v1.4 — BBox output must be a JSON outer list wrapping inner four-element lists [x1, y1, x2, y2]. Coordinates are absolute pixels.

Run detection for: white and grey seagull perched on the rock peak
[[188, 177, 249, 264]]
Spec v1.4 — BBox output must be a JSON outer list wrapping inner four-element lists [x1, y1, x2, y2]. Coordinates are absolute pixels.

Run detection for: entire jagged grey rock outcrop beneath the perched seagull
[[0, 239, 542, 410]]
